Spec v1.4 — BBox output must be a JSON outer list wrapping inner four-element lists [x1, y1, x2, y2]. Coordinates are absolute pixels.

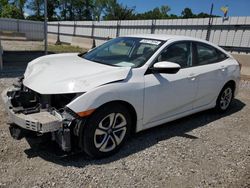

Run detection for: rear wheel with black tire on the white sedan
[[215, 84, 234, 113]]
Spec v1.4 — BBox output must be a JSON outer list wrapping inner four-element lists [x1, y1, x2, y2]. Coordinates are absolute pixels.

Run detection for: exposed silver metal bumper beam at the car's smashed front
[[2, 88, 63, 133]]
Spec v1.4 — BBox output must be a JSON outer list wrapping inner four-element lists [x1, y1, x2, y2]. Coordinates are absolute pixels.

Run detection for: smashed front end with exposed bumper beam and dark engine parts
[[2, 78, 84, 152]]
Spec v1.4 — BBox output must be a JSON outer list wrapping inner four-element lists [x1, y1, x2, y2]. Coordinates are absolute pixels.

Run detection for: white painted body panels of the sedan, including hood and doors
[[21, 35, 240, 131]]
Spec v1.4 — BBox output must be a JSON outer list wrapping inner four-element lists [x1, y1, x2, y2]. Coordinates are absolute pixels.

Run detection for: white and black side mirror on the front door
[[151, 61, 181, 74]]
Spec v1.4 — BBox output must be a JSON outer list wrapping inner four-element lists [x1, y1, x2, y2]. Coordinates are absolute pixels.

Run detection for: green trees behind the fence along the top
[[0, 0, 219, 21]]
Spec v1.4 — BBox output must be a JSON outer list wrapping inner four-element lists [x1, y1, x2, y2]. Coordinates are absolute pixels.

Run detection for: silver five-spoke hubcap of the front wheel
[[94, 113, 127, 152]]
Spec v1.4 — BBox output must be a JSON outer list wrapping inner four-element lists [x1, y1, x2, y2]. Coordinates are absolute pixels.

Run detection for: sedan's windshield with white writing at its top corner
[[82, 37, 163, 67]]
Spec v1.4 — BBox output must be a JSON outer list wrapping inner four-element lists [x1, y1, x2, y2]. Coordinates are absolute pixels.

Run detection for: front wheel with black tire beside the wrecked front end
[[82, 104, 131, 158]]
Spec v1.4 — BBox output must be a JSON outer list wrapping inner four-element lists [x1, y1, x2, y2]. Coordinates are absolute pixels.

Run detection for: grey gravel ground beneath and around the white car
[[0, 78, 250, 187]]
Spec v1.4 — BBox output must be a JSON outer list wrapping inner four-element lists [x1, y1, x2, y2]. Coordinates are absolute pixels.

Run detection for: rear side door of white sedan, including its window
[[193, 42, 227, 108]]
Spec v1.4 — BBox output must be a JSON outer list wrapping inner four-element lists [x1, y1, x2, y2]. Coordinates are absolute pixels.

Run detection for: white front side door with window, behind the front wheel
[[143, 42, 198, 125]]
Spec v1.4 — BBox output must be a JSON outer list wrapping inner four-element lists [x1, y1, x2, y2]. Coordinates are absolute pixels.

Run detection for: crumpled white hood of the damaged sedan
[[23, 53, 131, 94]]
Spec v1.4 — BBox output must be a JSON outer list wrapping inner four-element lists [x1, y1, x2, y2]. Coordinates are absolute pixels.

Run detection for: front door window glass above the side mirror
[[157, 42, 192, 68]]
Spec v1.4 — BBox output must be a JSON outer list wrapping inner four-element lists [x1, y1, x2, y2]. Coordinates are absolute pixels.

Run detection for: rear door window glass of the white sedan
[[196, 43, 227, 65]]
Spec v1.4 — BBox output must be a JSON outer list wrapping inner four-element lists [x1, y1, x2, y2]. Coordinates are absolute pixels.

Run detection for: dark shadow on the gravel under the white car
[[24, 99, 245, 168]]
